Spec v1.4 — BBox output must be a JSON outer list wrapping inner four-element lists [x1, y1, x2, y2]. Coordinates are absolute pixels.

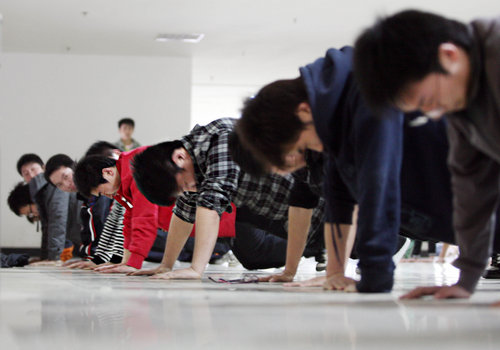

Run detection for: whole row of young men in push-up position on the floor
[[3, 10, 500, 298]]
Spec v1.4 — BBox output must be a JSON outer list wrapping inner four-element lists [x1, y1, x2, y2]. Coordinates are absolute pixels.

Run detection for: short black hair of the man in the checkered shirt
[[132, 140, 183, 206]]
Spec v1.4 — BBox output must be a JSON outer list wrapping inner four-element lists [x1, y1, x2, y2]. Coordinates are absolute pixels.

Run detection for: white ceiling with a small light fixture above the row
[[0, 0, 500, 85]]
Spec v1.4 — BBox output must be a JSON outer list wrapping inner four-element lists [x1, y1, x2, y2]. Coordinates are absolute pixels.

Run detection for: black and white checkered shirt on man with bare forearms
[[174, 118, 293, 223]]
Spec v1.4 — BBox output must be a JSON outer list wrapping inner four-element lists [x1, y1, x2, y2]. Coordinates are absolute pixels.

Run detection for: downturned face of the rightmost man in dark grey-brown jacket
[[398, 73, 467, 119]]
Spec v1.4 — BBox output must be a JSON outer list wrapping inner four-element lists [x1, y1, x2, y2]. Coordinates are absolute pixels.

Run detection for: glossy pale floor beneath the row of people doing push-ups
[[0, 259, 500, 350]]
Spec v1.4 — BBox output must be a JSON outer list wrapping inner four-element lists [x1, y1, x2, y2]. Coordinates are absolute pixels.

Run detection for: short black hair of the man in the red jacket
[[73, 155, 116, 198]]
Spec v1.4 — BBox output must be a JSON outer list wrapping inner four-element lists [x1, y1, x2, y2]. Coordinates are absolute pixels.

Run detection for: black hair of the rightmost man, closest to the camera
[[353, 10, 471, 113]]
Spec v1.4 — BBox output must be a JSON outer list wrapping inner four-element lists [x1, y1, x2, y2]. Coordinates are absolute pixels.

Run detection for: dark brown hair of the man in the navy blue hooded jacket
[[236, 77, 308, 167]]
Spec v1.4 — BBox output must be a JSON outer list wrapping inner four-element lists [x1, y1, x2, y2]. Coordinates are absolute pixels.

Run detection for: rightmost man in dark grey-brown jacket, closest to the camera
[[354, 10, 500, 299]]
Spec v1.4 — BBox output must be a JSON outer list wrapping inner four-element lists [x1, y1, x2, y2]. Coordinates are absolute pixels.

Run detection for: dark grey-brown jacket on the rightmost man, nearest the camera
[[448, 18, 500, 292]]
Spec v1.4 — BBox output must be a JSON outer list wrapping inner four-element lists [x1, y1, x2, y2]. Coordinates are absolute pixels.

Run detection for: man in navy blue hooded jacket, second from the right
[[236, 47, 403, 292]]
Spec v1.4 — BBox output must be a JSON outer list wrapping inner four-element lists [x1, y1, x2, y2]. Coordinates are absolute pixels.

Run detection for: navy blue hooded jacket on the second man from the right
[[300, 47, 403, 292]]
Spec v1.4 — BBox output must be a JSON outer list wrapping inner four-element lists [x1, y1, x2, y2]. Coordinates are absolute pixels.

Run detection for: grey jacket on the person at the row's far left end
[[29, 174, 80, 260]]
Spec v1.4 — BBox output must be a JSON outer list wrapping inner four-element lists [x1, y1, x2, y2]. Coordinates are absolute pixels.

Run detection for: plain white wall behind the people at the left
[[0, 53, 191, 247]]
